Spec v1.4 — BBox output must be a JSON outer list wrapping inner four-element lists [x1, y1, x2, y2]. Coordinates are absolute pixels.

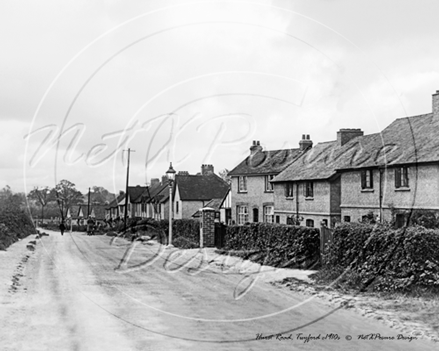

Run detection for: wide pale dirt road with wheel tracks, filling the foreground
[[0, 232, 437, 351]]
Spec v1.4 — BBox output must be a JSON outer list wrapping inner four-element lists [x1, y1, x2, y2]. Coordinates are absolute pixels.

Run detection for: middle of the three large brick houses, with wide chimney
[[272, 129, 364, 227]]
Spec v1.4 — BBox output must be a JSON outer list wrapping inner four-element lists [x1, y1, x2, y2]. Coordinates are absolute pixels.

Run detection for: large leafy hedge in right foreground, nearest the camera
[[321, 223, 439, 292]]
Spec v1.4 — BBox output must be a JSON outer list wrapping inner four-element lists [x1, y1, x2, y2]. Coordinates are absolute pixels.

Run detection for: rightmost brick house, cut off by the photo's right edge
[[339, 91, 439, 226]]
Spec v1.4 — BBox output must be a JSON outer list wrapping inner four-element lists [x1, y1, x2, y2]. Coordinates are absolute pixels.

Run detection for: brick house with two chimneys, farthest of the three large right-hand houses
[[228, 141, 306, 224]]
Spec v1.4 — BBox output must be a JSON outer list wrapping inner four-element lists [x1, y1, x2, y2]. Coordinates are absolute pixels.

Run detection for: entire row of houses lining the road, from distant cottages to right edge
[[106, 91, 439, 227]]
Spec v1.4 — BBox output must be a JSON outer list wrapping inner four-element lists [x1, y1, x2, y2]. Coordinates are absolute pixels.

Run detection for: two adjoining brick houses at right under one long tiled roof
[[272, 92, 439, 227]]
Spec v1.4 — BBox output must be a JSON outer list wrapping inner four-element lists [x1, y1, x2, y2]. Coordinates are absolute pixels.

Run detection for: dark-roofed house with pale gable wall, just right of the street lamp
[[173, 165, 229, 219]]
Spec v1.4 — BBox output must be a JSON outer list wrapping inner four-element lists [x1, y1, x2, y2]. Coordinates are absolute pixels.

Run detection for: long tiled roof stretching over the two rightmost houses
[[273, 113, 439, 183]]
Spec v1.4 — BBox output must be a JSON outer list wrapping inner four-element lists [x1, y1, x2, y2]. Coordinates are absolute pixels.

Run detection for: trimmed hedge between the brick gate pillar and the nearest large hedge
[[225, 223, 320, 268]]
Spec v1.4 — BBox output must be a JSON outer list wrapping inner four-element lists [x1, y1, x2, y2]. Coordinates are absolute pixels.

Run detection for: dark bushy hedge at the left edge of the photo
[[0, 200, 36, 250]]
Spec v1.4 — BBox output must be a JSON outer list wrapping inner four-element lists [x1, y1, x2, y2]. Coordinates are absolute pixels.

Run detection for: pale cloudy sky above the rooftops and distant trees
[[0, 0, 439, 193]]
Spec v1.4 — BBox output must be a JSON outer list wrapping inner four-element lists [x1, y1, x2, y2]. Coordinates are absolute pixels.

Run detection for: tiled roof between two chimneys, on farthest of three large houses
[[229, 149, 304, 176]]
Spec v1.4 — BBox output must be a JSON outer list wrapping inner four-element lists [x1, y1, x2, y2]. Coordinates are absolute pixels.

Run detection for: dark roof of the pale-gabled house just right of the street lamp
[[175, 174, 229, 201]]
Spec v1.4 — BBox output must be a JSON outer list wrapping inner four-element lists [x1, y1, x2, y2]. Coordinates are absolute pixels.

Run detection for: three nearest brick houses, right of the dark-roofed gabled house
[[229, 91, 439, 227]]
